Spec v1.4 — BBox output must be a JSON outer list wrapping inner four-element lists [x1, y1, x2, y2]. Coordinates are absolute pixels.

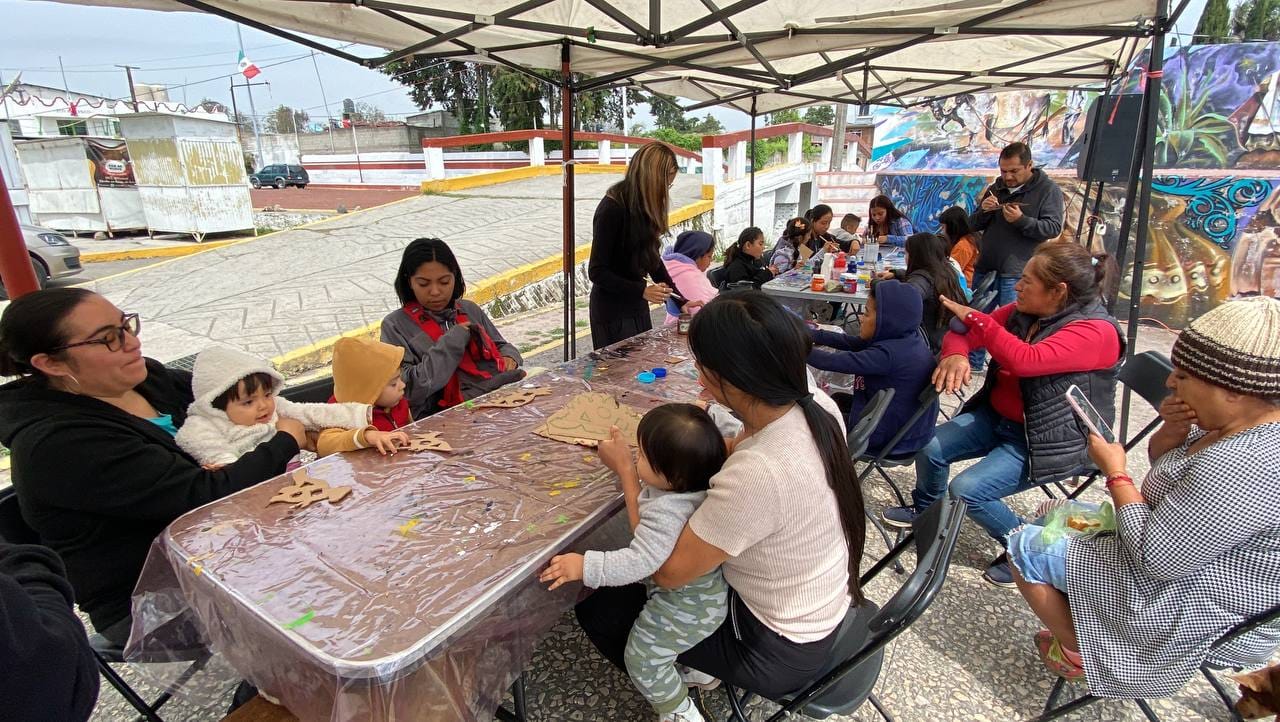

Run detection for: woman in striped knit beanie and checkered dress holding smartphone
[[1009, 297, 1280, 698]]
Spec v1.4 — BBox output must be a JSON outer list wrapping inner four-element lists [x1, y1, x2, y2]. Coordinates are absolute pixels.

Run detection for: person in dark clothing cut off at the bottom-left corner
[[0, 543, 99, 722]]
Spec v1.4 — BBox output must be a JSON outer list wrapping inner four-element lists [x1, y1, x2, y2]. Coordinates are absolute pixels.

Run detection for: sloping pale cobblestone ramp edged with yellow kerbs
[[91, 174, 701, 361]]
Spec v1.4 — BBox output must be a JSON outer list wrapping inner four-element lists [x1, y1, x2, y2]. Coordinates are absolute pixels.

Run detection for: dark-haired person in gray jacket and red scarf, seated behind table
[[381, 238, 525, 419]]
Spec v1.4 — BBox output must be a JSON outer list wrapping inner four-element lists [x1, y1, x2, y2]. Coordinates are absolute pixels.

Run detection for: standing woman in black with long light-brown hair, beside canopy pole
[[586, 142, 684, 348]]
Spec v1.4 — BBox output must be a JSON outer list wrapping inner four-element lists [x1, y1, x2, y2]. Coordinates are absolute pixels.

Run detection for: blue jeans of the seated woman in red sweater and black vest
[[911, 406, 1036, 544]]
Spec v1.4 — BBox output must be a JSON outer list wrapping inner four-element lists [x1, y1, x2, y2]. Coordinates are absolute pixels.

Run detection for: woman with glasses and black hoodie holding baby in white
[[0, 288, 306, 644]]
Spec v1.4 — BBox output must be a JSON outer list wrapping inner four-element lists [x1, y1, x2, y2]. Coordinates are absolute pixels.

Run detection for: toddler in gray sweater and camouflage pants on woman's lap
[[540, 403, 728, 722]]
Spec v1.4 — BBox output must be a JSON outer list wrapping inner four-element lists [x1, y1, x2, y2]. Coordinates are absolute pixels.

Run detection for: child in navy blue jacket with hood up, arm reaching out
[[809, 279, 938, 457]]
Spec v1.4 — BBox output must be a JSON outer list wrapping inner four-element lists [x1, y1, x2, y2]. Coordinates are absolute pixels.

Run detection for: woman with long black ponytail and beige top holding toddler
[[577, 291, 865, 696]]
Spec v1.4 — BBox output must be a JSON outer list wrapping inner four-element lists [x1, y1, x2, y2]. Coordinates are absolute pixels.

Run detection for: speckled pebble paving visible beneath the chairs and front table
[[93, 329, 1269, 722]]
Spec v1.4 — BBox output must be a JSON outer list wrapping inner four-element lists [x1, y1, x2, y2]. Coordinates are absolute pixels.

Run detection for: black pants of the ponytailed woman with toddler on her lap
[[575, 584, 836, 698]]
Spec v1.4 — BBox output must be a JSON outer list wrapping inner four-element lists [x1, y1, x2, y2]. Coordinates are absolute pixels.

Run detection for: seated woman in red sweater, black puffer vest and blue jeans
[[883, 243, 1124, 589]]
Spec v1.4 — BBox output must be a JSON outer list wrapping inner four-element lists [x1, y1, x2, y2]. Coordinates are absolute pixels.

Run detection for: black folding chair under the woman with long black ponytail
[[723, 494, 964, 722]]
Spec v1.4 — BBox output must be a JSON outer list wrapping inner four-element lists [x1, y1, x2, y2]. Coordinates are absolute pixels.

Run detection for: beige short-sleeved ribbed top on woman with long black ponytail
[[689, 392, 850, 643]]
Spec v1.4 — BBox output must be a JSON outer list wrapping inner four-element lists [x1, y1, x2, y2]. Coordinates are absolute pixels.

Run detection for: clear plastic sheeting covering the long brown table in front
[[127, 329, 699, 721]]
